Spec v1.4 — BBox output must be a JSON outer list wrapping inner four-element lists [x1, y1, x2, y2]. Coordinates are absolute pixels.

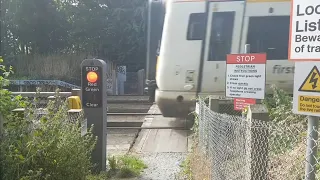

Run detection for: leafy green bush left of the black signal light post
[[0, 58, 96, 180]]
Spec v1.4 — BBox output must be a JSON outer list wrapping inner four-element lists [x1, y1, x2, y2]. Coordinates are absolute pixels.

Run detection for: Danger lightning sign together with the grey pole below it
[[293, 61, 320, 180]]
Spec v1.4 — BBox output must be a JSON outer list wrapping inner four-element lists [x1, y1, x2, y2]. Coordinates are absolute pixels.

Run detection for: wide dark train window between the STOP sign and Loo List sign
[[247, 16, 290, 60]]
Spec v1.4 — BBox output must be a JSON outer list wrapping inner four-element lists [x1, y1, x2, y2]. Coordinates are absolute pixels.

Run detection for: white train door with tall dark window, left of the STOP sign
[[200, 1, 245, 94]]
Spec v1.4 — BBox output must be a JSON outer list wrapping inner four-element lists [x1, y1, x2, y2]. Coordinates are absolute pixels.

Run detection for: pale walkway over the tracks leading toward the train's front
[[130, 105, 191, 180]]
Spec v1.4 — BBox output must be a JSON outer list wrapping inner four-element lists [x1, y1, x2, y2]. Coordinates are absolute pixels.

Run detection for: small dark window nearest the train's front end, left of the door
[[187, 13, 205, 40]]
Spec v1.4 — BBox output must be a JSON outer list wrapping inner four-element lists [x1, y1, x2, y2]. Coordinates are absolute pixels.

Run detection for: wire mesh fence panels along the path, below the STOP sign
[[197, 100, 320, 180]]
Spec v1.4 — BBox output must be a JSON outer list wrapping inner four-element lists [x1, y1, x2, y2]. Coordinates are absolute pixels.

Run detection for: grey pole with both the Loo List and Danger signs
[[288, 0, 320, 180]]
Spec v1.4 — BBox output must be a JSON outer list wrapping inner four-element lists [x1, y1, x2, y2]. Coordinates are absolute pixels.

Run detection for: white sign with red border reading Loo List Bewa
[[289, 0, 320, 61]]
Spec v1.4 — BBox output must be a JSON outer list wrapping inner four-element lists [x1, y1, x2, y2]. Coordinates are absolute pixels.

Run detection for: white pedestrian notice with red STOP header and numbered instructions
[[226, 53, 267, 99]]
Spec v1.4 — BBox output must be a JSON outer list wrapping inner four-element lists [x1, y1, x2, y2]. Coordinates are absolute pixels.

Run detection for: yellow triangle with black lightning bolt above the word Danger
[[299, 66, 320, 92]]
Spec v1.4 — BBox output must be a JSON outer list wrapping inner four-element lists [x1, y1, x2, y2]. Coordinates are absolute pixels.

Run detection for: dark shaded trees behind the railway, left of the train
[[1, 0, 147, 81]]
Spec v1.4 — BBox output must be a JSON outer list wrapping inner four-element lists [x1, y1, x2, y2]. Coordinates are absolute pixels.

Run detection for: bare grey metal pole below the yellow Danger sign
[[305, 116, 319, 180]]
